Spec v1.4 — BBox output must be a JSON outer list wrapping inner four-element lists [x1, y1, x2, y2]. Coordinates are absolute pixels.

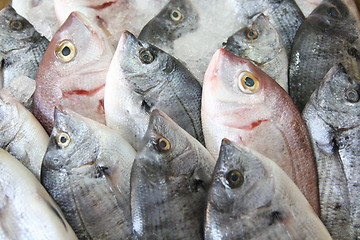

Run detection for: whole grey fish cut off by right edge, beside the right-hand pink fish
[[302, 63, 360, 239]]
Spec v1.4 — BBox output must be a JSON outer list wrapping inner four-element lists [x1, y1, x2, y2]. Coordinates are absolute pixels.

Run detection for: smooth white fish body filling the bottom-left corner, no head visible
[[0, 149, 77, 240]]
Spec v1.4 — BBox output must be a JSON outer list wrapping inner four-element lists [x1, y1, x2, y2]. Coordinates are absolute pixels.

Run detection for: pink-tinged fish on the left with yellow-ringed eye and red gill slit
[[34, 12, 115, 133]]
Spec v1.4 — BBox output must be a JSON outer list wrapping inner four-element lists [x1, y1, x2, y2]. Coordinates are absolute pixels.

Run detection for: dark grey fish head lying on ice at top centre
[[139, 0, 199, 48]]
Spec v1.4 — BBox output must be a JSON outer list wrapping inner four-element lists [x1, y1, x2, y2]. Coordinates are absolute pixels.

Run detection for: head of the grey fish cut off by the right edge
[[311, 63, 360, 129]]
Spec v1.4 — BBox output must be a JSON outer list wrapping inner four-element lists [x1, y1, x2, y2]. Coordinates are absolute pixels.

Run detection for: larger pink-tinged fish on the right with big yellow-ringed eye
[[201, 49, 319, 214]]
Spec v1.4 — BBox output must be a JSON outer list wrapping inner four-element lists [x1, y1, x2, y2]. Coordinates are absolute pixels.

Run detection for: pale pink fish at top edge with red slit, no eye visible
[[54, 0, 168, 46]]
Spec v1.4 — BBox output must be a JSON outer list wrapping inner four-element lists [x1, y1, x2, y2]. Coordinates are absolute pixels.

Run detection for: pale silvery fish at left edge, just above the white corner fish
[[0, 89, 49, 179]]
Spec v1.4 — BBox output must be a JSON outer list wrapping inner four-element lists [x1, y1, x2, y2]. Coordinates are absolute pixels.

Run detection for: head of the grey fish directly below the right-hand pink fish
[[207, 139, 275, 218]]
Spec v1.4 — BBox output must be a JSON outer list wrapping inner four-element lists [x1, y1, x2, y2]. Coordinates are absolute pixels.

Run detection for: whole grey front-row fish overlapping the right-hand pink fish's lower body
[[205, 139, 332, 239]]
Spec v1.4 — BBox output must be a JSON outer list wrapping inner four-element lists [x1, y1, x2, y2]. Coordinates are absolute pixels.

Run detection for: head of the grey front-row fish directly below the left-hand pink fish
[[42, 106, 99, 171]]
